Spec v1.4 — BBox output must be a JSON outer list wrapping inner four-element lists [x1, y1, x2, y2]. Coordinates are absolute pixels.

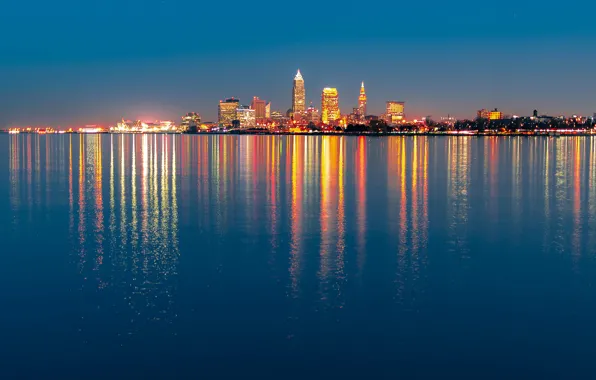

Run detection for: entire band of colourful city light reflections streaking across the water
[[7, 135, 596, 318]]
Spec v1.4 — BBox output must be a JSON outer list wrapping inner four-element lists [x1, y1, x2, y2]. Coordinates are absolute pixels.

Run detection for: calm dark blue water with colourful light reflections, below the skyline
[[0, 135, 596, 379]]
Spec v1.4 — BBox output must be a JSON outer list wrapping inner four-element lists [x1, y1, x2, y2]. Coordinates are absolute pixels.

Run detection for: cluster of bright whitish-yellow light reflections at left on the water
[[65, 136, 179, 332]]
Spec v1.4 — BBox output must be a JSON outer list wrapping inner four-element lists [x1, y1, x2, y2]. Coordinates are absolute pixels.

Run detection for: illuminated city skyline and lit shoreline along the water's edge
[[3, 70, 596, 136]]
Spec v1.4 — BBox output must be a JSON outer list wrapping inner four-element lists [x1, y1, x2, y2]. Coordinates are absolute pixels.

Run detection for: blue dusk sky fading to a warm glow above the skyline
[[0, 0, 596, 127]]
